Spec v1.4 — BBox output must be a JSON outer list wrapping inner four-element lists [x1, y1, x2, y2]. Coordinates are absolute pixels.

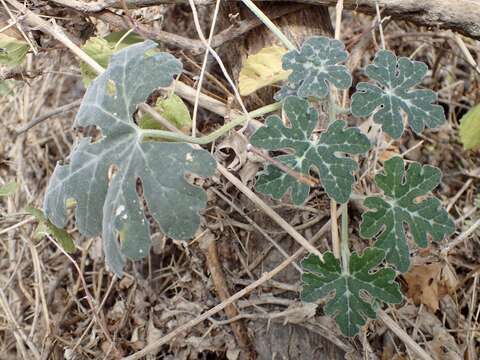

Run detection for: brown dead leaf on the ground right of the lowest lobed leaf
[[403, 263, 442, 312]]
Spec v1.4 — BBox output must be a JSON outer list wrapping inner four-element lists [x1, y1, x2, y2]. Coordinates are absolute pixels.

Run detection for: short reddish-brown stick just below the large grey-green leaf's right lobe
[[200, 232, 252, 352]]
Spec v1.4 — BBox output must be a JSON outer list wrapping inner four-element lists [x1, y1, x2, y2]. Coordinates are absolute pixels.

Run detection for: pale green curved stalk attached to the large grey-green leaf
[[138, 103, 282, 145]]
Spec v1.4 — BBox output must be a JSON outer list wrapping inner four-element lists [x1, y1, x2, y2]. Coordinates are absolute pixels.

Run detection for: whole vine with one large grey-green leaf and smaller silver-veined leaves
[[44, 37, 454, 336]]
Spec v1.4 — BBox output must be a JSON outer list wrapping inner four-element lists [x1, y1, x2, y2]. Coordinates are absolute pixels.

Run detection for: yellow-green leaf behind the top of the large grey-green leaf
[[80, 31, 143, 87]]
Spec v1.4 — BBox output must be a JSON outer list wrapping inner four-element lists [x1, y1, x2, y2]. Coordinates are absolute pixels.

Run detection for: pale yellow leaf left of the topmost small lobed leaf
[[238, 46, 291, 96]]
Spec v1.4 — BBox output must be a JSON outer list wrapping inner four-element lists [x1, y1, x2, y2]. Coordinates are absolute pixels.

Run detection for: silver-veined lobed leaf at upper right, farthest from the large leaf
[[352, 50, 445, 139]]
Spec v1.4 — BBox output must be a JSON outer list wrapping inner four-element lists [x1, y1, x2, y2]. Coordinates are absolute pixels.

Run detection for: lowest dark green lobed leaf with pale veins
[[302, 248, 402, 336]]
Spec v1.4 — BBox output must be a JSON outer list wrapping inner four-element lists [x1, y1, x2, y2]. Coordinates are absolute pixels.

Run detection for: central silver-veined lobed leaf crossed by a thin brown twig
[[250, 96, 370, 204]]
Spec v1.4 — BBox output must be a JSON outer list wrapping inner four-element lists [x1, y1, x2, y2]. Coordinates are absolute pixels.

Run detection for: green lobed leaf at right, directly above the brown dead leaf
[[360, 156, 455, 272]]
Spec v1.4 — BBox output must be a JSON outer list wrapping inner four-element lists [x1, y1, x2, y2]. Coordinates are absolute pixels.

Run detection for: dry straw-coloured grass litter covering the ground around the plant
[[0, 4, 480, 360]]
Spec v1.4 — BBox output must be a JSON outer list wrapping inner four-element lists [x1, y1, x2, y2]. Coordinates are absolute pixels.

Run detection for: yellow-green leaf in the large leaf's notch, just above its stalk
[[138, 93, 192, 133]]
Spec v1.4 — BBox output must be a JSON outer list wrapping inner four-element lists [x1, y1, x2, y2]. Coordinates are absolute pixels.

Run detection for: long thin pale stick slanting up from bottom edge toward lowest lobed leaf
[[123, 219, 330, 360]]
